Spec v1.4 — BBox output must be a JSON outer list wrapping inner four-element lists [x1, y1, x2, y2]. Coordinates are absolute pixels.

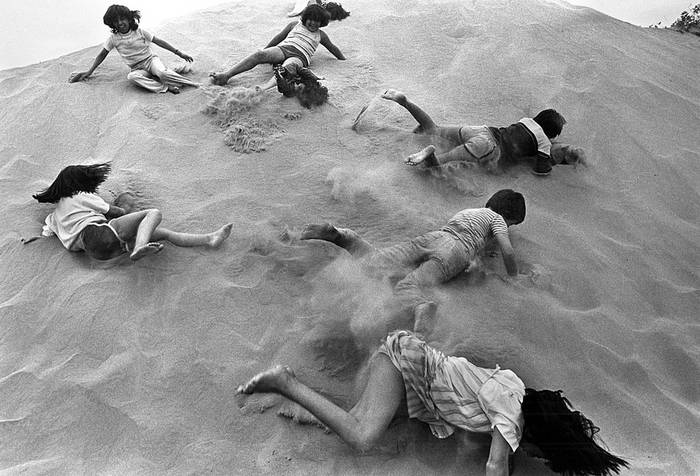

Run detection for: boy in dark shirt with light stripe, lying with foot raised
[[382, 89, 585, 175]]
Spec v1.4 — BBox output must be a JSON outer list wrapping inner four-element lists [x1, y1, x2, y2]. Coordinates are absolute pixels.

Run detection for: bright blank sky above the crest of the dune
[[0, 0, 700, 69]]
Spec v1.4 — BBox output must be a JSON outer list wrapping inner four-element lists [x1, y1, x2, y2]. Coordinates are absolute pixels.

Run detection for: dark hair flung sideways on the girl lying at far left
[[32, 162, 112, 203]]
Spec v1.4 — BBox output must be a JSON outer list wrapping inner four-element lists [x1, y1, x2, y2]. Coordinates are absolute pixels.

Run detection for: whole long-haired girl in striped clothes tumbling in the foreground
[[237, 331, 628, 476]]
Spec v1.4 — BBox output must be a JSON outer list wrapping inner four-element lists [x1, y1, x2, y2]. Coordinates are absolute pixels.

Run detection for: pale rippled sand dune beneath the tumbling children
[[0, 0, 700, 475]]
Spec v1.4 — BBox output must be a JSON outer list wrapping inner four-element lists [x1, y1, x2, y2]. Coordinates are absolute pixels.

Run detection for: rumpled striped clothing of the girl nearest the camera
[[379, 331, 525, 451]]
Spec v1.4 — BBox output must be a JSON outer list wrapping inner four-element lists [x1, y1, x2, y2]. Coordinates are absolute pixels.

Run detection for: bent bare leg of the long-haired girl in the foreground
[[238, 354, 405, 451]]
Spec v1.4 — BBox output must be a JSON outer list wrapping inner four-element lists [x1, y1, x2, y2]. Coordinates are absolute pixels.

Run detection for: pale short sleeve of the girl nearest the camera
[[478, 370, 525, 451]]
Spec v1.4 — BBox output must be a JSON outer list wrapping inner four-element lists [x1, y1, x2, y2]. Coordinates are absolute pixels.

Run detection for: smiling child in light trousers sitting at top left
[[68, 5, 199, 94]]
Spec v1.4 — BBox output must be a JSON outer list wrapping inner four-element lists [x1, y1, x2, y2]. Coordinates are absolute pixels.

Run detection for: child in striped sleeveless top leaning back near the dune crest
[[209, 3, 345, 86]]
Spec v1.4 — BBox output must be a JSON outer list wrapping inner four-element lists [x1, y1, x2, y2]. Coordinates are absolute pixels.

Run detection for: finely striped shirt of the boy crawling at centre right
[[442, 208, 508, 253]]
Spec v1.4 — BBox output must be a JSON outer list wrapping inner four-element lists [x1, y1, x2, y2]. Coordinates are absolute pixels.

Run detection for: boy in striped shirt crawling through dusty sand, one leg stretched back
[[301, 189, 525, 334]]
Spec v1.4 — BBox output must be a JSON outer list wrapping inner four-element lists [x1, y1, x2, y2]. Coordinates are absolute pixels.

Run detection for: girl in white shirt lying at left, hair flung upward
[[32, 163, 232, 260]]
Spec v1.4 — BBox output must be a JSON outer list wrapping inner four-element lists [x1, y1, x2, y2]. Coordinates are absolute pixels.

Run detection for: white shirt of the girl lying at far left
[[41, 192, 109, 251]]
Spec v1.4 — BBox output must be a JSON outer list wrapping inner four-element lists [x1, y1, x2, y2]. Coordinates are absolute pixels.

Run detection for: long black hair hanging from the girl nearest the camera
[[522, 388, 629, 476]]
